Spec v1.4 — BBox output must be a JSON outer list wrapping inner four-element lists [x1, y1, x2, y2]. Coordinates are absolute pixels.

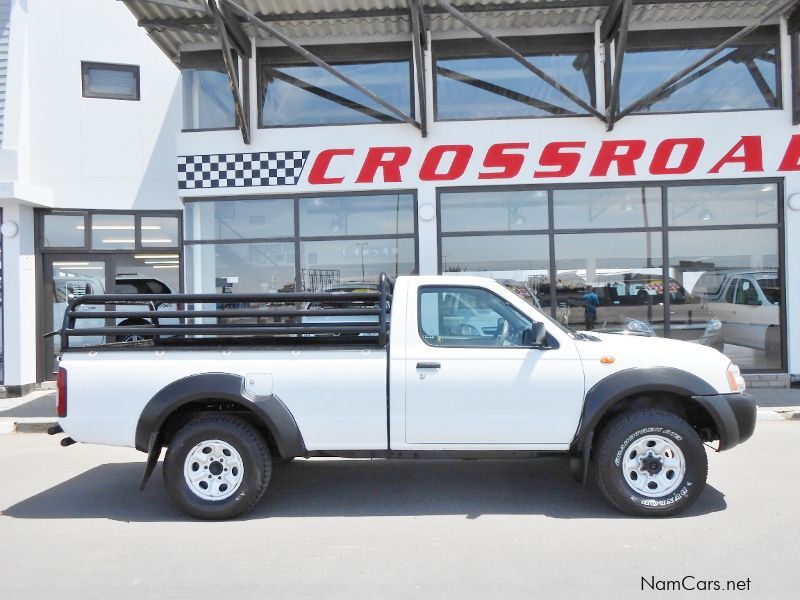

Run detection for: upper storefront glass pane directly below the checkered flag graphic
[[186, 198, 294, 240]]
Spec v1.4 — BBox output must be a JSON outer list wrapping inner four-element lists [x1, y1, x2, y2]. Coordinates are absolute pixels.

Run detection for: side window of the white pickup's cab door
[[419, 287, 532, 348]]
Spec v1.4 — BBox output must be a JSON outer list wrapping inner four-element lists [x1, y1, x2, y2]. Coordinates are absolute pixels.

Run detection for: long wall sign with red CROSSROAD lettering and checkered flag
[[178, 134, 800, 189]]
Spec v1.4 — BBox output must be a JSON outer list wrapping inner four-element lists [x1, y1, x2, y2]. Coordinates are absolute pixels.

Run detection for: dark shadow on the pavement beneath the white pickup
[[0, 458, 727, 522]]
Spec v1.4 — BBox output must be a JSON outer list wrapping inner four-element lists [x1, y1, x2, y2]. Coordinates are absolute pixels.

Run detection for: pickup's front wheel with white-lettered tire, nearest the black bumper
[[595, 409, 708, 517]]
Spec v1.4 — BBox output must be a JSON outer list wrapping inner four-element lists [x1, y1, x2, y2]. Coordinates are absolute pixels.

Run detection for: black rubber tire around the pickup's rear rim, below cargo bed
[[164, 415, 272, 519]]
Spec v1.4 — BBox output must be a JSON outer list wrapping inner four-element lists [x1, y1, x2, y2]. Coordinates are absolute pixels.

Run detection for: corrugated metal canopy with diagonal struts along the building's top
[[122, 0, 800, 135]]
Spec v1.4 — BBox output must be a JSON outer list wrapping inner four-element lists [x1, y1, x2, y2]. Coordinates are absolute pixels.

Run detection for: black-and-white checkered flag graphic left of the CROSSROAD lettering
[[178, 150, 309, 190]]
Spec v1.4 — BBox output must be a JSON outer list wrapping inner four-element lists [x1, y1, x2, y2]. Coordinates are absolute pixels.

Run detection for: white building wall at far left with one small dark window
[[0, 0, 181, 395]]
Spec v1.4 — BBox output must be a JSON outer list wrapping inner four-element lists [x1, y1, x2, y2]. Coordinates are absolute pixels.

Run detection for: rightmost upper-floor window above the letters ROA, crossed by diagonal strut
[[620, 27, 780, 113]]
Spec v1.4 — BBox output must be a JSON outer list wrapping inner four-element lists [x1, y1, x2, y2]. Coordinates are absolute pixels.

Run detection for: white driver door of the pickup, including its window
[[405, 285, 584, 449]]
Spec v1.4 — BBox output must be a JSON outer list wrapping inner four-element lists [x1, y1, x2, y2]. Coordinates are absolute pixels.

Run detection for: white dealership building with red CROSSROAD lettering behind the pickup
[[0, 0, 800, 394]]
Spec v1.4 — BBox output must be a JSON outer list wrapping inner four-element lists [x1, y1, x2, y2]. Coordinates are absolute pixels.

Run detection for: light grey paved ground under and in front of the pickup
[[0, 420, 800, 600]]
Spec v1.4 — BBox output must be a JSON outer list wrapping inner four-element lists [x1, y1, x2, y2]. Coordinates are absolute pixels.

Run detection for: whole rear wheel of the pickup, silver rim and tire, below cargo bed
[[164, 416, 272, 519]]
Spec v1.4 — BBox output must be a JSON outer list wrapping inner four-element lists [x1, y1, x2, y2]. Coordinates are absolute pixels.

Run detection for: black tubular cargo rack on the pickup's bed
[[54, 273, 393, 350]]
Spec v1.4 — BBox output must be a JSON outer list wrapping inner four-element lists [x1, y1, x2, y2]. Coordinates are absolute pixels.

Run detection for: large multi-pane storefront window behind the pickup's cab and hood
[[439, 181, 784, 371]]
